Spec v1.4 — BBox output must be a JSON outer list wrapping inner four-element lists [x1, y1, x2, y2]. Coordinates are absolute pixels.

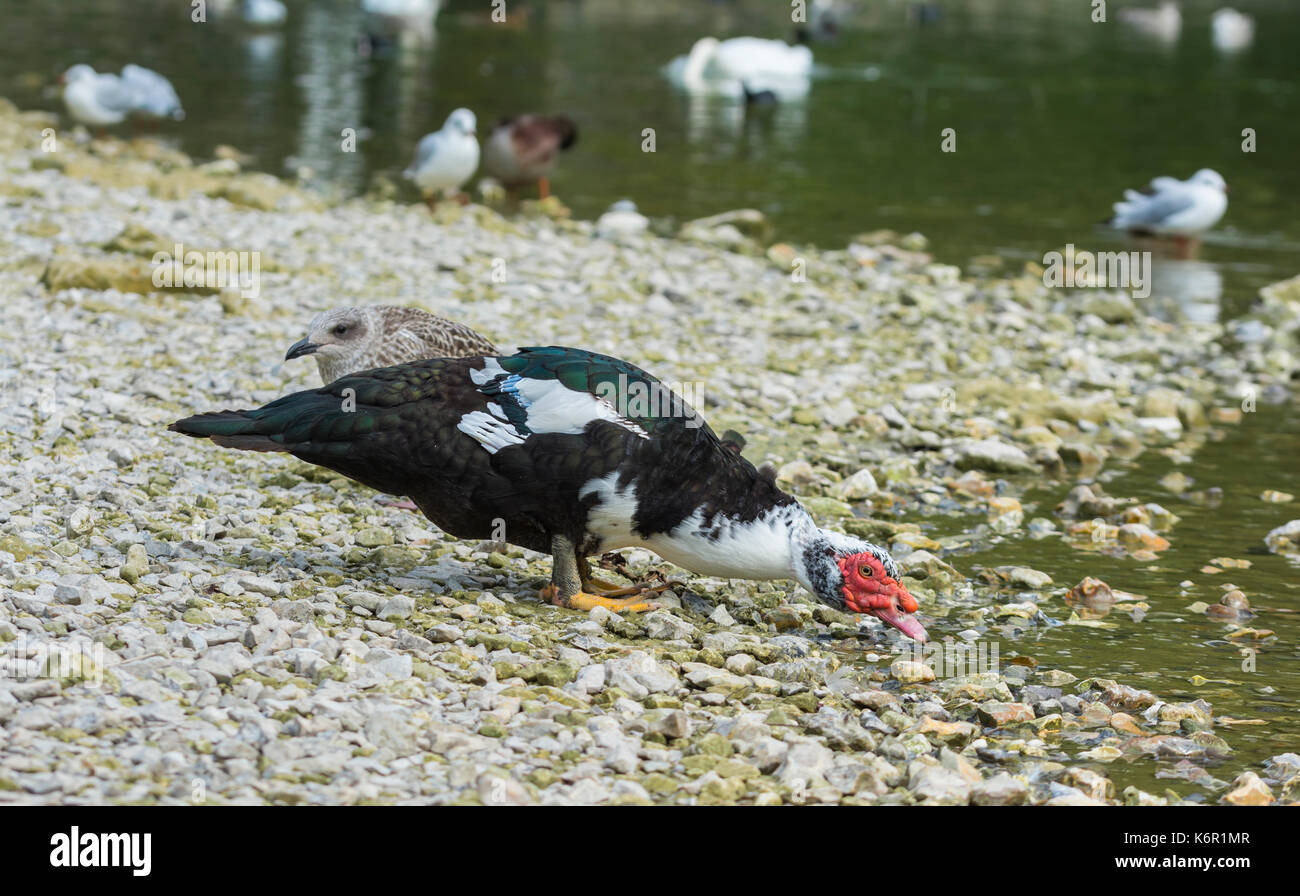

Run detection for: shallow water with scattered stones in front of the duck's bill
[[841, 404, 1300, 795]]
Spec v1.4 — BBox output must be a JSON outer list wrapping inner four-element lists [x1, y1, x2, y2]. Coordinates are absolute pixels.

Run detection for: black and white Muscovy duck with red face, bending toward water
[[172, 346, 926, 640]]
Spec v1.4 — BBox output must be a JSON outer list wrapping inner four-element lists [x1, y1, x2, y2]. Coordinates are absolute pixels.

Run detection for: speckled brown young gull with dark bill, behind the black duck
[[285, 304, 497, 382]]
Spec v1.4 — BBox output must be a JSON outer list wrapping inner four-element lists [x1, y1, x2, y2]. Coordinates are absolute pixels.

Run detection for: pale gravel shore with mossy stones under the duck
[[0, 100, 1300, 805]]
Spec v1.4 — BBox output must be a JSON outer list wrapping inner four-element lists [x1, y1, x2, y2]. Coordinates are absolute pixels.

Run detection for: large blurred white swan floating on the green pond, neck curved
[[666, 38, 813, 100]]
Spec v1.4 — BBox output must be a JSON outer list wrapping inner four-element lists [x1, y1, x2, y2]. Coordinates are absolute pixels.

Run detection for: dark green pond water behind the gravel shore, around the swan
[[10, 0, 1300, 306]]
